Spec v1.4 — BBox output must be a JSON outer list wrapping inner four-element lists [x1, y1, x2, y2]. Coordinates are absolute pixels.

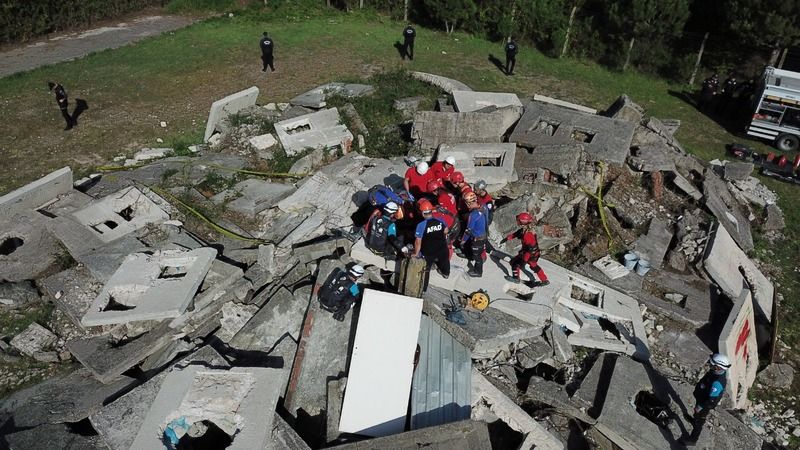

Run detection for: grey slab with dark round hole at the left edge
[[0, 209, 64, 282]]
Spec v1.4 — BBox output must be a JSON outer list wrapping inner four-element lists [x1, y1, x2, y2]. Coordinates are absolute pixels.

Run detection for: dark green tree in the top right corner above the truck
[[725, 0, 800, 65]]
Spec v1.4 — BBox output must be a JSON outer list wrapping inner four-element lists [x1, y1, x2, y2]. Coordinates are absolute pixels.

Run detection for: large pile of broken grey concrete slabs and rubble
[[0, 72, 786, 449]]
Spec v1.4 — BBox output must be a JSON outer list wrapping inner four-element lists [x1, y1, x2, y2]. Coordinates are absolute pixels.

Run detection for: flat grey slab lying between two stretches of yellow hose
[[211, 178, 294, 217]]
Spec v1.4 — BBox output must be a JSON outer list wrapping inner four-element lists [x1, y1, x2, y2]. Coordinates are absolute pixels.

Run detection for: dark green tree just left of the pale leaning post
[[608, 0, 689, 70]]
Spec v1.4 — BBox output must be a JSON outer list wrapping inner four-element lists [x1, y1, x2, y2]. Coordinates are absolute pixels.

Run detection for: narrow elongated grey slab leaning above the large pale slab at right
[[703, 169, 753, 252]]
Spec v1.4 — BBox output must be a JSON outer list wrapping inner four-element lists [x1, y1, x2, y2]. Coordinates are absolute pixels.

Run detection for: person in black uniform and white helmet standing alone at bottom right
[[678, 353, 731, 445]]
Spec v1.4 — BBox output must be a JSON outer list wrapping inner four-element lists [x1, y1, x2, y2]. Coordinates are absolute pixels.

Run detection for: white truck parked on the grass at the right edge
[[747, 67, 800, 152]]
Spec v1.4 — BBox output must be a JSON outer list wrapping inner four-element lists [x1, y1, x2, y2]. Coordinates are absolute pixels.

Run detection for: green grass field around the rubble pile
[[0, 6, 800, 398]]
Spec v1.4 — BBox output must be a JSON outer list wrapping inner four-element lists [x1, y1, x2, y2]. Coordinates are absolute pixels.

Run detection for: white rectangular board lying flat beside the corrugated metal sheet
[[339, 289, 422, 437]]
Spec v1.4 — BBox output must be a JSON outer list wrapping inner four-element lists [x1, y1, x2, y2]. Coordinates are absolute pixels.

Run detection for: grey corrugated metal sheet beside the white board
[[410, 312, 472, 429]]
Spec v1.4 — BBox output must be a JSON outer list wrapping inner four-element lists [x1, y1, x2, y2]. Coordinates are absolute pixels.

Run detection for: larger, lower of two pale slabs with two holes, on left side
[[81, 247, 217, 326]]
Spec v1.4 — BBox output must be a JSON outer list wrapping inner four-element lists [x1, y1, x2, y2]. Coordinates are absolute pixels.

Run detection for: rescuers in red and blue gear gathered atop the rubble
[[319, 156, 549, 320]]
